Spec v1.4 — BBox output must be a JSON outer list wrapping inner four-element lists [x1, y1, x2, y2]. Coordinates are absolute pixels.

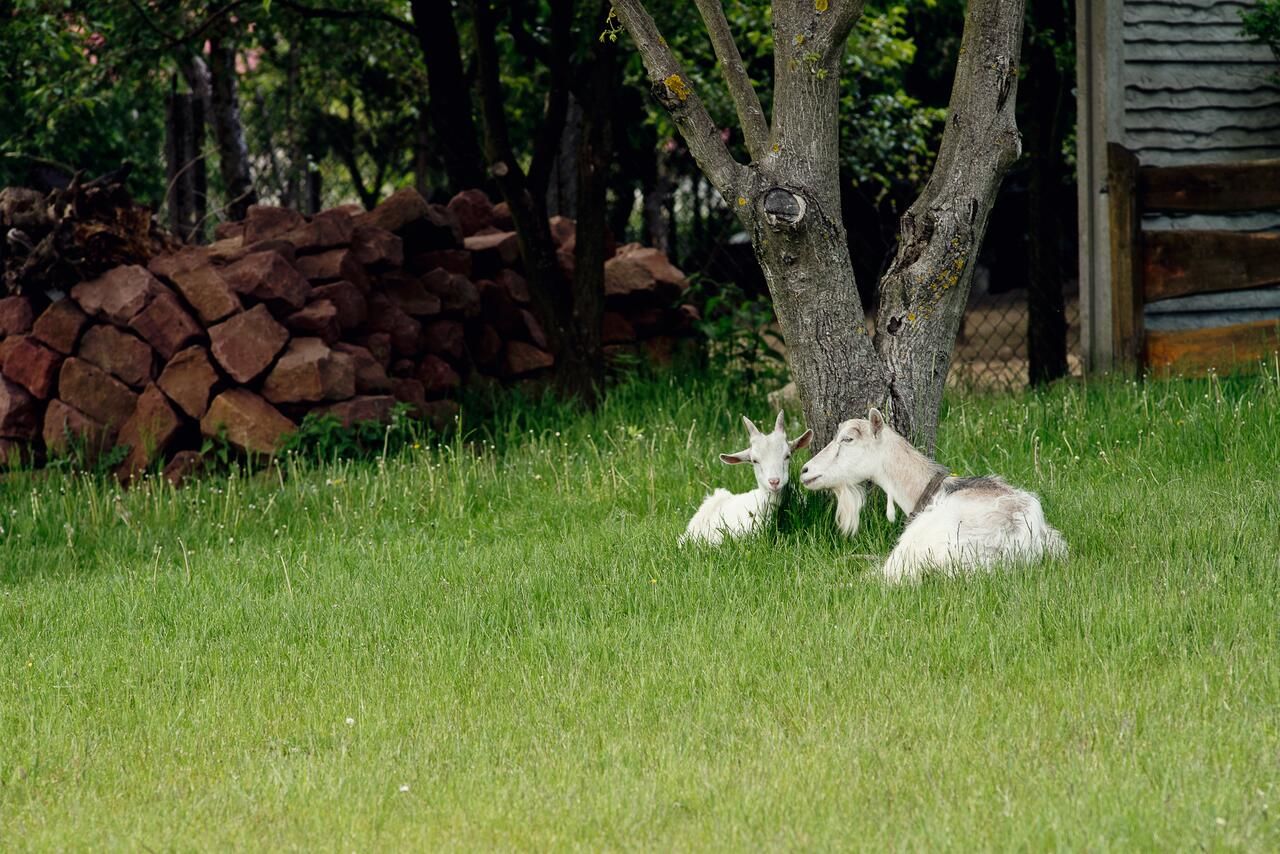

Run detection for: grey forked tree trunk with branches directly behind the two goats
[[614, 0, 1023, 451]]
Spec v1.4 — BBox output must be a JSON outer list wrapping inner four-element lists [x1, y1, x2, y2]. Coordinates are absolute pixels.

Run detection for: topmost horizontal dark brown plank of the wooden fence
[[1138, 160, 1280, 213]]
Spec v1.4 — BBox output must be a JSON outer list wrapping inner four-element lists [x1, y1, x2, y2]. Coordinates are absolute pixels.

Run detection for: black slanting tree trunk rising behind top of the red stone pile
[[410, 0, 488, 192]]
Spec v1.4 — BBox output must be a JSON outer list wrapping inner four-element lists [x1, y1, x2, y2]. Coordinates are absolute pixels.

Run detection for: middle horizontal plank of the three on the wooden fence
[[1142, 230, 1280, 302]]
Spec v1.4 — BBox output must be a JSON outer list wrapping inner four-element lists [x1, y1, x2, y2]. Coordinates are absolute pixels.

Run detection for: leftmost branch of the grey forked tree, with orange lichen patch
[[613, 0, 746, 200]]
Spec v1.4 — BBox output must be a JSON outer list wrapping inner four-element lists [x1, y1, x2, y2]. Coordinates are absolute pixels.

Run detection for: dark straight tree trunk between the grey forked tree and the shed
[[1024, 0, 1075, 385]]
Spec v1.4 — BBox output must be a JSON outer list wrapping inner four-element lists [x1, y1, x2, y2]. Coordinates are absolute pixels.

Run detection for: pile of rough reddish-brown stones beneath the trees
[[0, 189, 696, 480]]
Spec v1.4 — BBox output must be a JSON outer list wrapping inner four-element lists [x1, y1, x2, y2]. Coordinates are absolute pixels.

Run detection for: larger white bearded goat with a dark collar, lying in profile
[[800, 408, 1066, 581]]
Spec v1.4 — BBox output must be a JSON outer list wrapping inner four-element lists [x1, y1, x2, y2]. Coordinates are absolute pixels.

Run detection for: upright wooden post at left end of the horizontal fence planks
[[1107, 142, 1142, 366]]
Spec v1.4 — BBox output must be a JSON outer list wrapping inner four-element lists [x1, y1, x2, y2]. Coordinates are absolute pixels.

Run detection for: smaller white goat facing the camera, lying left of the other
[[680, 412, 813, 545]]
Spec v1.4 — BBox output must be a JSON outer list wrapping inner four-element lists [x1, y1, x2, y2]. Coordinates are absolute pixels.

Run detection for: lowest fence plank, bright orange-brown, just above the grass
[[1146, 320, 1280, 374]]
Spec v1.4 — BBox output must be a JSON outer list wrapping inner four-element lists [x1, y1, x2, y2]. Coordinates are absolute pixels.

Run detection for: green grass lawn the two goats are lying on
[[0, 376, 1280, 850]]
